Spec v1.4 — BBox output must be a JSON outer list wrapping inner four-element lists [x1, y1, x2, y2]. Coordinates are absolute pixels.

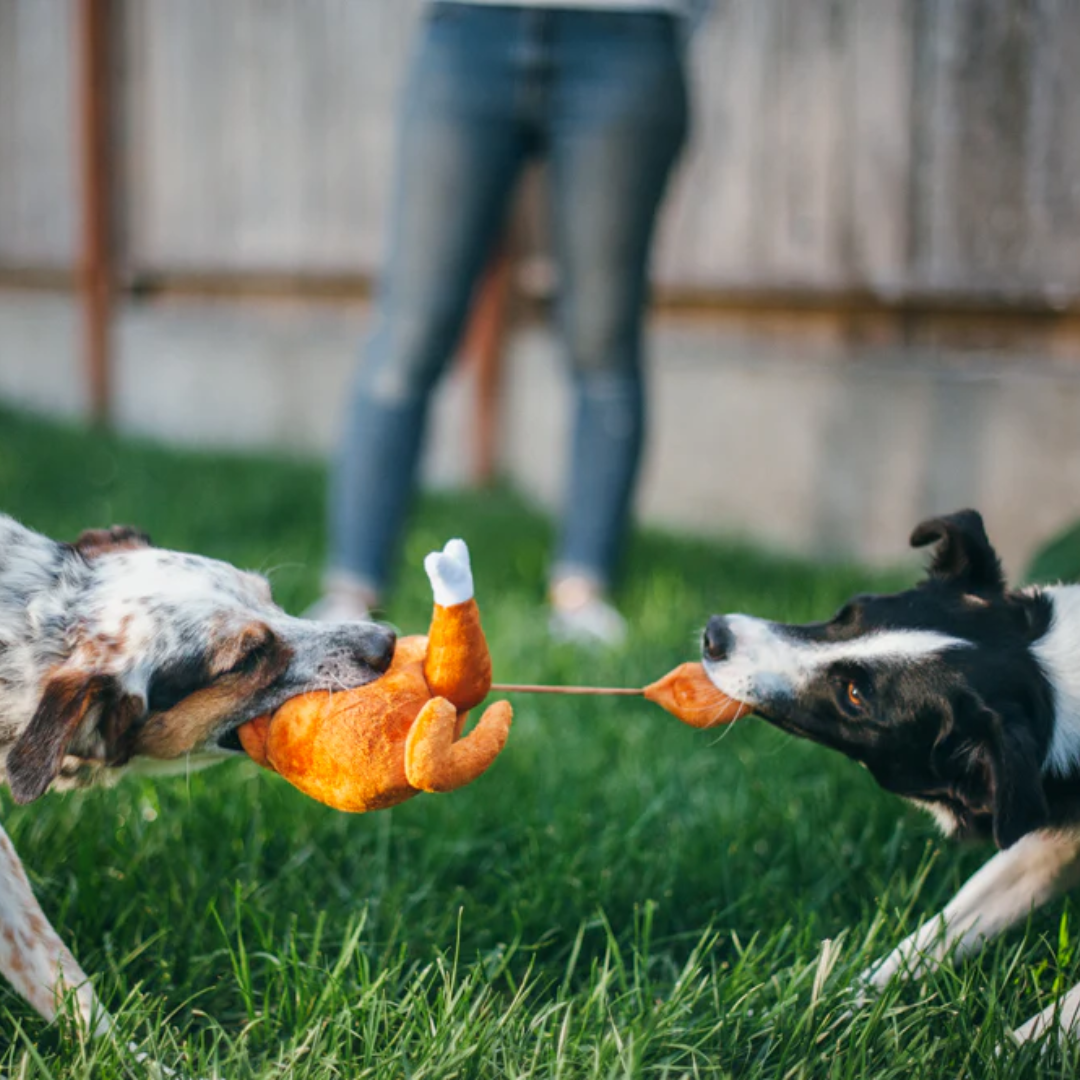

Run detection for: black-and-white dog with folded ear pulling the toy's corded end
[[703, 510, 1080, 1041]]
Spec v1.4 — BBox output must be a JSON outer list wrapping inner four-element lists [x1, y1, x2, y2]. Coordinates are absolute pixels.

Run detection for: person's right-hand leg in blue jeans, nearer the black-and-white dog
[[550, 11, 688, 636]]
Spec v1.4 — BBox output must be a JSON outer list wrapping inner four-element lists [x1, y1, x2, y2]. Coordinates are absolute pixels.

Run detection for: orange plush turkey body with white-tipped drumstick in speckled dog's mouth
[[238, 540, 513, 813]]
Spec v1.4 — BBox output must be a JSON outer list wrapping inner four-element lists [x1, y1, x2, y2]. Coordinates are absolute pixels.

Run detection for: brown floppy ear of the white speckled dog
[[6, 671, 146, 804]]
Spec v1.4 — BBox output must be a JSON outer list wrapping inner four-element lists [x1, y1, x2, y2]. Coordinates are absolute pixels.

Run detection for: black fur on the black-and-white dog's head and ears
[[704, 511, 1067, 848]]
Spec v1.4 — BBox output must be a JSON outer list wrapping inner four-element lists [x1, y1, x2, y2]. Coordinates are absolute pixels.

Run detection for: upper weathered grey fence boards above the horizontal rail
[[0, 0, 1080, 307]]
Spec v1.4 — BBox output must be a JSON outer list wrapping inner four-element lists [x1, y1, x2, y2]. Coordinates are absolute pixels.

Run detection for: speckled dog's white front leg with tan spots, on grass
[[0, 828, 109, 1035]]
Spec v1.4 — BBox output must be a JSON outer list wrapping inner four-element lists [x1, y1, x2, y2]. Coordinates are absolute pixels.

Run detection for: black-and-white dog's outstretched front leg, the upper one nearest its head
[[861, 831, 1080, 991]]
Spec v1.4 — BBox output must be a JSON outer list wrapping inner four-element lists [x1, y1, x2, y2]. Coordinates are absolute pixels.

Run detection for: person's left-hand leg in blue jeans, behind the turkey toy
[[324, 4, 528, 617]]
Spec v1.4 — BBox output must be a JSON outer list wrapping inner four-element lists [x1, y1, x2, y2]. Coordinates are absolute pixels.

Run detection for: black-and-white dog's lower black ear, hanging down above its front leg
[[932, 693, 1050, 849]]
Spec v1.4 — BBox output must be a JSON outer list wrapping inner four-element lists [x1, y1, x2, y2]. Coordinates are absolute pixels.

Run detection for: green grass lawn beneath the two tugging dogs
[[0, 413, 1080, 1080]]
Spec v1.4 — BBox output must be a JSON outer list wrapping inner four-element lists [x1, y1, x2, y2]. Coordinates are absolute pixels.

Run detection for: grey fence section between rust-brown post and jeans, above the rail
[[127, 0, 416, 272]]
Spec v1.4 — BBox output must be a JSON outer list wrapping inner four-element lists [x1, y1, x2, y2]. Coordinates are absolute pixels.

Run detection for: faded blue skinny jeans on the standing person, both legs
[[330, 3, 688, 592]]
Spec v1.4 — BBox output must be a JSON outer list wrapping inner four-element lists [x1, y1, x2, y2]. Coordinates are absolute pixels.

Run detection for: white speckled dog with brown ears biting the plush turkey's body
[[0, 515, 394, 1032]]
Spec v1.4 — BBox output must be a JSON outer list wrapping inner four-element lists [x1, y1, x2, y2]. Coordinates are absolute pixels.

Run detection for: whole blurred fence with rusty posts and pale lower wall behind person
[[0, 0, 1080, 572]]
